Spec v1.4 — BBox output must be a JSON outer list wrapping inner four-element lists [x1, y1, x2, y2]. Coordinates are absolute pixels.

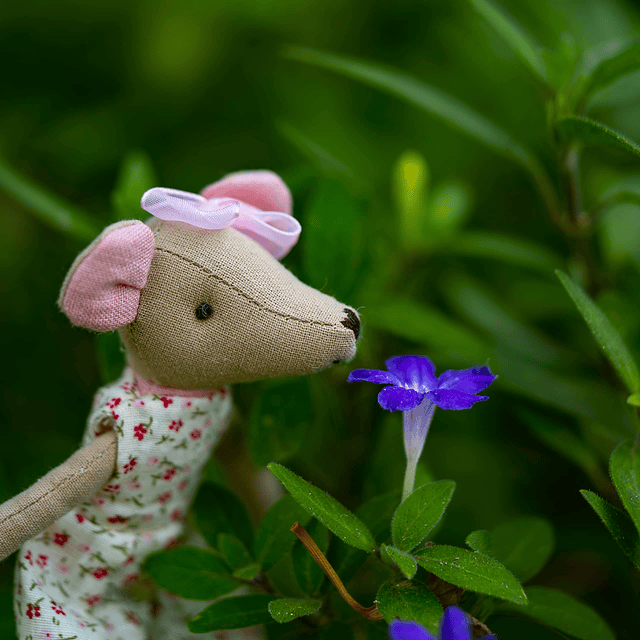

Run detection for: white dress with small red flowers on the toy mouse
[[14, 368, 238, 640]]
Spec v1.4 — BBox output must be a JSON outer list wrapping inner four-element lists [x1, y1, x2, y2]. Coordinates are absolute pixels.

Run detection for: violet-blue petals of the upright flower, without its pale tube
[[349, 356, 496, 411]]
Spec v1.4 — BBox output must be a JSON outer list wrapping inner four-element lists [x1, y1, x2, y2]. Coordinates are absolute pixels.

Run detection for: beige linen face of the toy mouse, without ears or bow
[[121, 220, 356, 389]]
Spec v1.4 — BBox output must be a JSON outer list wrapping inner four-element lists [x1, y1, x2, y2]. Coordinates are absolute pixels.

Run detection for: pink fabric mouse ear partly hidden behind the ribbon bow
[[201, 170, 292, 215]]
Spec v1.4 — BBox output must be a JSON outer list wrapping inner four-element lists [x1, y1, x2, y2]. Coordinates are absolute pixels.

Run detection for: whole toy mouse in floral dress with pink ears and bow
[[0, 171, 360, 640]]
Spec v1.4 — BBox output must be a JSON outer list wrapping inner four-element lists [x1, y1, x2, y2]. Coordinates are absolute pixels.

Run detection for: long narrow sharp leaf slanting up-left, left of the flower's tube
[[267, 462, 376, 552]]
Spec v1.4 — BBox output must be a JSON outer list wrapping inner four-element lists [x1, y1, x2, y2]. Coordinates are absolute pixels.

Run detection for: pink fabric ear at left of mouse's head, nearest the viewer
[[58, 220, 155, 331]]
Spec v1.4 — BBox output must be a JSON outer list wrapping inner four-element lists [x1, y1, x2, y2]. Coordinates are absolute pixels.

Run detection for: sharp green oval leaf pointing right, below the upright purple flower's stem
[[413, 545, 527, 604]]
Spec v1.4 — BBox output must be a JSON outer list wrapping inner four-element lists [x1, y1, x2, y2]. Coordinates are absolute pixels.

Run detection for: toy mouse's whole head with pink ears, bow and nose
[[59, 171, 360, 390]]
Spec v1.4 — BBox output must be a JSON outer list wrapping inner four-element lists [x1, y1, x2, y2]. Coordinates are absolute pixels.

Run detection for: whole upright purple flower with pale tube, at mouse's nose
[[348, 356, 496, 500]]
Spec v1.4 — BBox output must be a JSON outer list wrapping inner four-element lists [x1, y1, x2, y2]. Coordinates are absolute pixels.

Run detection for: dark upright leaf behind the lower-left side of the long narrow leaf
[[253, 495, 311, 571]]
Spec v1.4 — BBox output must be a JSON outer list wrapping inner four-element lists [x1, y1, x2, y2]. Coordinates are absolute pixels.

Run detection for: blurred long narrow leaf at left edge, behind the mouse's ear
[[0, 160, 101, 242]]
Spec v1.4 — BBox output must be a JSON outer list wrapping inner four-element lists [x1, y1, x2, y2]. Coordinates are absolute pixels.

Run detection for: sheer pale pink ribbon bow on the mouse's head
[[140, 187, 302, 260]]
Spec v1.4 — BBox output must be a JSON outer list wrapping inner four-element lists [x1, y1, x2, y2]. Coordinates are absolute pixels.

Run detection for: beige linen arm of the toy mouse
[[0, 431, 118, 560]]
